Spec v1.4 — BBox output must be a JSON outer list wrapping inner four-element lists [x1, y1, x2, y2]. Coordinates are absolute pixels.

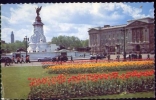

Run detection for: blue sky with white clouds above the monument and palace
[[1, 2, 154, 43]]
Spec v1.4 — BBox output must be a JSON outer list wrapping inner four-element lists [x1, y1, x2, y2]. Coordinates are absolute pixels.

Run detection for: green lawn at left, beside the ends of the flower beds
[[1, 66, 57, 99]]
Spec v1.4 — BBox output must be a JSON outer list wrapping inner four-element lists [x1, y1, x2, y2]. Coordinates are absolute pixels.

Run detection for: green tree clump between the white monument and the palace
[[51, 35, 88, 49]]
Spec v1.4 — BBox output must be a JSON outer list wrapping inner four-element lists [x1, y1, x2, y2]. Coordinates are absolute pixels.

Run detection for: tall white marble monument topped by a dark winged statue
[[27, 6, 57, 52]]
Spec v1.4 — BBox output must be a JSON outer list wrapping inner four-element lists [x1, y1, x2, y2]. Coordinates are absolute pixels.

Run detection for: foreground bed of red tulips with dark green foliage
[[28, 70, 155, 99]]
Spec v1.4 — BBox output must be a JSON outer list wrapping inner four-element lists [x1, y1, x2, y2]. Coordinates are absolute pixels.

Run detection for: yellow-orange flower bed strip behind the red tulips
[[46, 61, 154, 74]]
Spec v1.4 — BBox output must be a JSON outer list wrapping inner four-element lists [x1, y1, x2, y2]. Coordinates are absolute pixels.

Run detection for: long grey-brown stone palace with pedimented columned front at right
[[88, 17, 155, 54]]
